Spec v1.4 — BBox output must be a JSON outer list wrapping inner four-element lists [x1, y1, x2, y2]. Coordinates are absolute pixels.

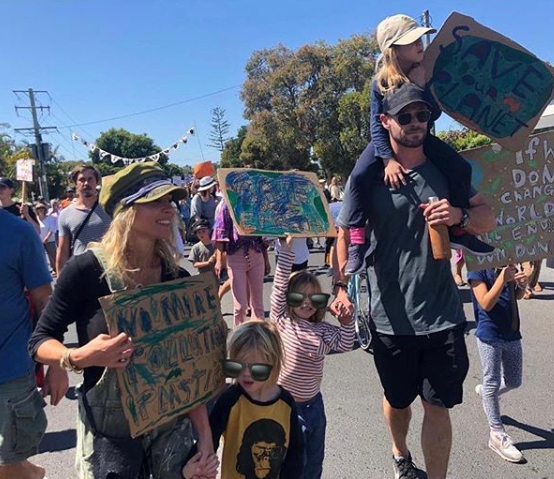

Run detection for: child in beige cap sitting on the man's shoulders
[[346, 15, 494, 274]]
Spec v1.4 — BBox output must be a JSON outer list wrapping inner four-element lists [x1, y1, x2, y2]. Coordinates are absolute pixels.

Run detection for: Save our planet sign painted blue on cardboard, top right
[[423, 13, 554, 151]]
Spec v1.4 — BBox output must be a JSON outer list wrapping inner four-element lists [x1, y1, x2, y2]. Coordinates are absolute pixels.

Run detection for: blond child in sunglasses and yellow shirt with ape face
[[206, 320, 305, 479]]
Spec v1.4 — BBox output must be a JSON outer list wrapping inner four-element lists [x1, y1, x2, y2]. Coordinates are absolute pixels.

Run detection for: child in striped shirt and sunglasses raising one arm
[[270, 236, 355, 479]]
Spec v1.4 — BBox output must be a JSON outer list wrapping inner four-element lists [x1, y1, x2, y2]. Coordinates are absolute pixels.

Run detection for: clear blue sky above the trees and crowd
[[0, 0, 554, 165]]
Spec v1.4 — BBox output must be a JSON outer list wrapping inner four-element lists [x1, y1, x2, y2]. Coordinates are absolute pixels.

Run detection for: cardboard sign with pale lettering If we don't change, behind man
[[462, 131, 554, 271]]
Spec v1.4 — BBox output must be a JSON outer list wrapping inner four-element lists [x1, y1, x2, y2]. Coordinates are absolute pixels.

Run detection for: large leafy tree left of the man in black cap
[[240, 35, 377, 176]]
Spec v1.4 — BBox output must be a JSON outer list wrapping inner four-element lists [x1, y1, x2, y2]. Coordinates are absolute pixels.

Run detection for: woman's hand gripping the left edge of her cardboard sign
[[70, 333, 134, 368]]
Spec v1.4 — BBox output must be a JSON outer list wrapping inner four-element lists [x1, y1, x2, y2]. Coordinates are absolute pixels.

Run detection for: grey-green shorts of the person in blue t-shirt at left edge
[[0, 371, 47, 466]]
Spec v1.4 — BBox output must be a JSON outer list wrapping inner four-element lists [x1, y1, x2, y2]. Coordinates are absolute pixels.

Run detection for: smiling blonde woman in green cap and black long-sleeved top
[[29, 162, 217, 479]]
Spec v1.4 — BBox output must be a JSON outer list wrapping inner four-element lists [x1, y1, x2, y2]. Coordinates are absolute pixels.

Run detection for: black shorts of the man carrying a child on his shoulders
[[373, 323, 469, 409]]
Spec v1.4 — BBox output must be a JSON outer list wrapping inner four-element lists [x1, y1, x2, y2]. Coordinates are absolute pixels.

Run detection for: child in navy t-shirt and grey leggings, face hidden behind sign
[[467, 265, 527, 462]]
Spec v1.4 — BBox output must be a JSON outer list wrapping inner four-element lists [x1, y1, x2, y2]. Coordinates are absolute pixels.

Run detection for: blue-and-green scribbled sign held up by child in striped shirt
[[218, 168, 336, 237]]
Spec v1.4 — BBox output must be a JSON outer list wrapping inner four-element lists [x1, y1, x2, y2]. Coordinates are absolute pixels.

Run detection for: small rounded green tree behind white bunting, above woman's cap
[[89, 128, 168, 168]]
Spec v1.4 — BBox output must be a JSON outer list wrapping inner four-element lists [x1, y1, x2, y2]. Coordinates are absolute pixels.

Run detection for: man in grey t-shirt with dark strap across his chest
[[56, 165, 111, 275]]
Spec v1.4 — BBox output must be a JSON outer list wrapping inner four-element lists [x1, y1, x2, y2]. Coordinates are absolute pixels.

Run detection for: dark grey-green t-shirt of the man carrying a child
[[367, 161, 465, 335]]
